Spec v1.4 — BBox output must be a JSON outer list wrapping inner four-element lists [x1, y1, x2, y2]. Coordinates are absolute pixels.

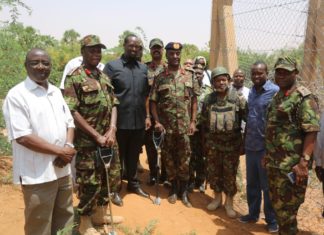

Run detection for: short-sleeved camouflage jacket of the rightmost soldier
[[265, 86, 319, 173]]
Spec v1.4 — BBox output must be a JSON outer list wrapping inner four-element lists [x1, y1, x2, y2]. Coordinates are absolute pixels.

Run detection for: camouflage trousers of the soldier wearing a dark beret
[[161, 133, 191, 181]]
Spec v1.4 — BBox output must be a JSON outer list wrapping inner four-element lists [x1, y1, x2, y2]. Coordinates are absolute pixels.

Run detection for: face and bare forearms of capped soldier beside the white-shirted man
[[73, 45, 117, 147]]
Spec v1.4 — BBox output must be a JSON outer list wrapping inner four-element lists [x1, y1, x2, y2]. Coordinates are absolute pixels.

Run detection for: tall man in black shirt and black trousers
[[103, 34, 151, 201]]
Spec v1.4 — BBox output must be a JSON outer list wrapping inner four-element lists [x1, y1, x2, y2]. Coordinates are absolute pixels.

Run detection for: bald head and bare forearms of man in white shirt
[[16, 48, 76, 166]]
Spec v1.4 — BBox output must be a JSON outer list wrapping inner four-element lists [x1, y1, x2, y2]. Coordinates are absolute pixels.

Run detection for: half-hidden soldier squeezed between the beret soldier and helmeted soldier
[[189, 64, 213, 193]]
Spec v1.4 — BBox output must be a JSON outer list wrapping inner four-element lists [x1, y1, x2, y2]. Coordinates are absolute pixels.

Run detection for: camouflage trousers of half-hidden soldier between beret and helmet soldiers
[[189, 129, 206, 184]]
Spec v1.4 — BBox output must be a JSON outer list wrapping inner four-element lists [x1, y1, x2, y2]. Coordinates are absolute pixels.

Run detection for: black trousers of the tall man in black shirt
[[117, 128, 145, 190]]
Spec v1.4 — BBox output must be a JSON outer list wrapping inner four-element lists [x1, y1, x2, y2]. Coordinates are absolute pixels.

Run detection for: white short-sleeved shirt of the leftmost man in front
[[3, 77, 74, 184]]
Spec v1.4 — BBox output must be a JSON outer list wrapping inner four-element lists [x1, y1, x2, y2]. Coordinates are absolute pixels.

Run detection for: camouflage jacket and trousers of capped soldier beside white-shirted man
[[64, 66, 121, 215]]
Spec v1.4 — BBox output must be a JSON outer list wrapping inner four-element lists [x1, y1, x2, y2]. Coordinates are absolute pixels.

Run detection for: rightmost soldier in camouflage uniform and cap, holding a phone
[[265, 58, 319, 234]]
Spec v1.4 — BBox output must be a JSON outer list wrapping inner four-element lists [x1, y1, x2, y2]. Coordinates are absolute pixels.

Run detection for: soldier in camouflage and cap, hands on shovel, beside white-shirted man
[[64, 35, 122, 235]]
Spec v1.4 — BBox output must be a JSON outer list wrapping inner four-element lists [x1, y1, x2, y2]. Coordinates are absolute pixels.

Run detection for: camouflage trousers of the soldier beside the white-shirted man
[[75, 146, 121, 215]]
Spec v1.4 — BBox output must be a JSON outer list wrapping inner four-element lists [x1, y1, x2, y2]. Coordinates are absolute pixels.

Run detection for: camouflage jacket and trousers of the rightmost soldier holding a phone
[[265, 85, 319, 234]]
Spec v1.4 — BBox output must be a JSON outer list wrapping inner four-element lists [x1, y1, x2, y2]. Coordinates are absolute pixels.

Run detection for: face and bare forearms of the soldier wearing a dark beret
[[150, 50, 198, 135]]
